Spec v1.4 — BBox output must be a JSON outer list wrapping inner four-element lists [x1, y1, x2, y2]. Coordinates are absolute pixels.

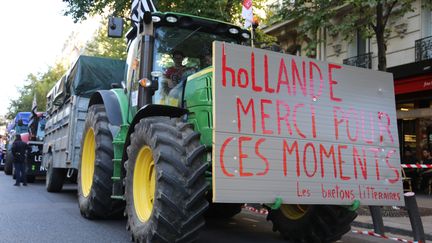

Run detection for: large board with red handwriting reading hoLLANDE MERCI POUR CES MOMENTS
[[213, 42, 403, 205]]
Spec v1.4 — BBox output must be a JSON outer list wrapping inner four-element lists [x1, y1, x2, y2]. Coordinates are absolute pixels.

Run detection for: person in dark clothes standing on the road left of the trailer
[[12, 134, 27, 186]]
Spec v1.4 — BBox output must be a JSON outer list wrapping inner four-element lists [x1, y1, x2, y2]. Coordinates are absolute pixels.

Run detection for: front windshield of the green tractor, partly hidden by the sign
[[153, 26, 238, 106]]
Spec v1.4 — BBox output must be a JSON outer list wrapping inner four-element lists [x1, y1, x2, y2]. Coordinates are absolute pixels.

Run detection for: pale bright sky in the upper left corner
[[0, 0, 98, 115]]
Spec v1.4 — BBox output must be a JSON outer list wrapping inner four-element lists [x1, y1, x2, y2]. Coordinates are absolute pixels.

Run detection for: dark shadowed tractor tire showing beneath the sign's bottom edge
[[267, 205, 357, 243]]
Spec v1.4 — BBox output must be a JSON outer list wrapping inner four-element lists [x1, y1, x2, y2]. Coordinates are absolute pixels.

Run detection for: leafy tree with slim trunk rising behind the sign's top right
[[276, 0, 415, 71]]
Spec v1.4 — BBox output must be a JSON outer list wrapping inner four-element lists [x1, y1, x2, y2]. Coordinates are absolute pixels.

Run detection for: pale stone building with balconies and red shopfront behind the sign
[[264, 0, 432, 162]]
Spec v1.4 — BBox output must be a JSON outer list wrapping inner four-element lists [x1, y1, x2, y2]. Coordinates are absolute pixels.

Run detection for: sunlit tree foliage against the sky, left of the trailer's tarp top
[[6, 63, 66, 119]]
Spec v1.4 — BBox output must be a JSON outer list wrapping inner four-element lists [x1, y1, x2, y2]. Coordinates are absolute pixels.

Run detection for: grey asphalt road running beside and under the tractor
[[0, 171, 394, 243]]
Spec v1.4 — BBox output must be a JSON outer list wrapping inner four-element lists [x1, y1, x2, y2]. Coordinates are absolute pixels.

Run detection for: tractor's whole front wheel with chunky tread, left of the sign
[[125, 117, 208, 242]]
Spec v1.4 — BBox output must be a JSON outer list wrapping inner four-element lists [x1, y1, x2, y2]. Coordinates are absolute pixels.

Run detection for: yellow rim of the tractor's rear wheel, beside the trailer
[[80, 128, 96, 197]]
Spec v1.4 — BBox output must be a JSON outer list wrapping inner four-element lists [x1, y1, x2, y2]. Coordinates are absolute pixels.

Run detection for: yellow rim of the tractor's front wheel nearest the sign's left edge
[[133, 146, 156, 222]]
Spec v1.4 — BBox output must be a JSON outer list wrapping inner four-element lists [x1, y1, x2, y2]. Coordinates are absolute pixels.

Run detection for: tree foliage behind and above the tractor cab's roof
[[65, 0, 275, 50]]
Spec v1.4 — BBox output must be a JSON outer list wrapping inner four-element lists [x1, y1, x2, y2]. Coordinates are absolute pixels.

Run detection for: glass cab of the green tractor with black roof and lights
[[116, 12, 250, 112]]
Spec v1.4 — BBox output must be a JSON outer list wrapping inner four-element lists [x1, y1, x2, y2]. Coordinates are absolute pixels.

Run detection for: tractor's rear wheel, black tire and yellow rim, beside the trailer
[[78, 104, 124, 219]]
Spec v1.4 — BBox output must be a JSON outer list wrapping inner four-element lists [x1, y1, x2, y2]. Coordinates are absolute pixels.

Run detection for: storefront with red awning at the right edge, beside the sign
[[387, 60, 432, 163]]
